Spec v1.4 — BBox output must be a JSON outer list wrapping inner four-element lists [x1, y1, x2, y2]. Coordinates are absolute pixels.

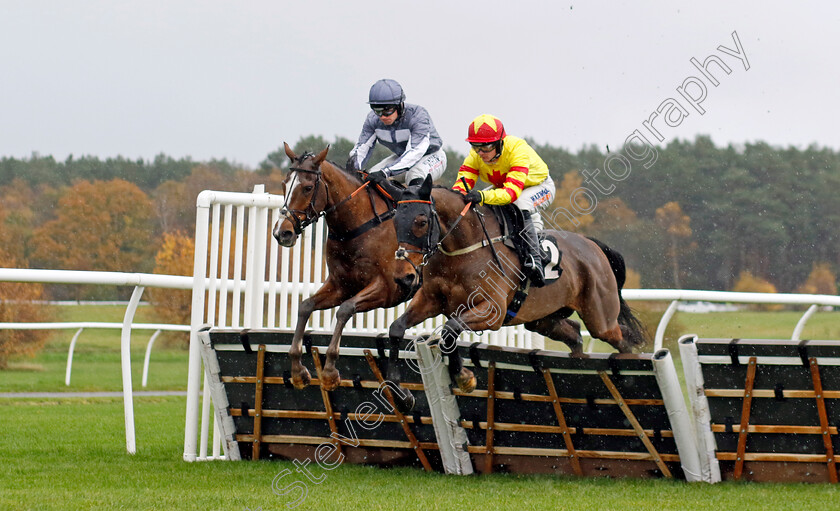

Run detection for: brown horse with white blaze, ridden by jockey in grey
[[272, 144, 411, 390]]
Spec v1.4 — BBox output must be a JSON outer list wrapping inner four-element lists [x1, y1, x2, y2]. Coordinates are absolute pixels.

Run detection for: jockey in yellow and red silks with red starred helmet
[[452, 114, 555, 287]]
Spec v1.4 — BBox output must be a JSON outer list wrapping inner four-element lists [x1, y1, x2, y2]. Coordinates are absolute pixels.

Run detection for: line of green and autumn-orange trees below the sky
[[0, 135, 840, 300]]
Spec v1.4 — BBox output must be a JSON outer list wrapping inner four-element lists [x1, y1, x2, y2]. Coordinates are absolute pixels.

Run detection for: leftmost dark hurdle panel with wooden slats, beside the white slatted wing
[[199, 329, 441, 471]]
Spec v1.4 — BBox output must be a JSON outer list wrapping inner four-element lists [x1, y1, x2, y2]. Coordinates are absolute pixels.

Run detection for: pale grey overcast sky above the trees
[[0, 0, 840, 168]]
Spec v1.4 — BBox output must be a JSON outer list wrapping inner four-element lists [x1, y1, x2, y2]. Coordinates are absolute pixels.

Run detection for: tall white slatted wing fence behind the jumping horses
[[183, 189, 543, 461]]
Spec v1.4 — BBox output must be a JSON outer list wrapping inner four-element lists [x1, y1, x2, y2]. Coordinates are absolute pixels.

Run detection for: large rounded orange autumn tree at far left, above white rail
[[32, 179, 155, 272]]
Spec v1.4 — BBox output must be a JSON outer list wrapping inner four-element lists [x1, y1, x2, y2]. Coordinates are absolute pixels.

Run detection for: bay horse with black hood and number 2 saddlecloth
[[388, 179, 645, 412]]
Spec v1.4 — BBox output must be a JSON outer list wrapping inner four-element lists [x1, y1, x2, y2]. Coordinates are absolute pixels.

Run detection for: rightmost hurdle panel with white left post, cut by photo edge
[[679, 335, 840, 483]]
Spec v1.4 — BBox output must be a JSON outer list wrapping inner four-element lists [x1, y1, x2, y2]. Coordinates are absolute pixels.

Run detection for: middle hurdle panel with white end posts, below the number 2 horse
[[417, 338, 700, 481]]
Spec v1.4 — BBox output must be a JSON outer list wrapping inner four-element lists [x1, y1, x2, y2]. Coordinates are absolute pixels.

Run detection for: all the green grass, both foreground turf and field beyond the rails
[[0, 306, 840, 511]]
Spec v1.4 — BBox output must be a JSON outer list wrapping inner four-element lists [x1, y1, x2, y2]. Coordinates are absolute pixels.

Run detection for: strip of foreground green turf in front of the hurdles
[[0, 397, 840, 511]]
